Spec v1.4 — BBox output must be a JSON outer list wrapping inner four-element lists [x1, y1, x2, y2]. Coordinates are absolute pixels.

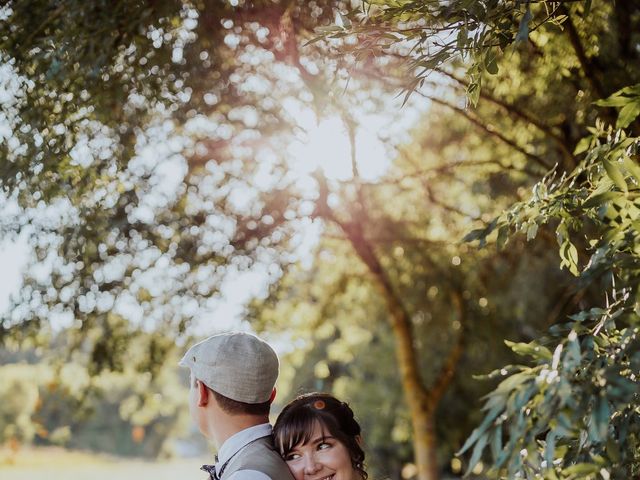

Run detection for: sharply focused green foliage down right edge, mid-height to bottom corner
[[460, 77, 640, 479]]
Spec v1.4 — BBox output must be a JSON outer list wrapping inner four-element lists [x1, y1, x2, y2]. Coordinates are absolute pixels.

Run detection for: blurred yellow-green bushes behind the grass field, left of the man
[[0, 352, 189, 458]]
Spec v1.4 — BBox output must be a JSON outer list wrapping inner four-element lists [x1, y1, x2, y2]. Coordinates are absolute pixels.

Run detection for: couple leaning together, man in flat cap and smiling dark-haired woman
[[180, 332, 367, 480]]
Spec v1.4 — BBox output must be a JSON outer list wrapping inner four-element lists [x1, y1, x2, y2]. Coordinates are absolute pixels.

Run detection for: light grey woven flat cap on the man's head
[[179, 332, 279, 403]]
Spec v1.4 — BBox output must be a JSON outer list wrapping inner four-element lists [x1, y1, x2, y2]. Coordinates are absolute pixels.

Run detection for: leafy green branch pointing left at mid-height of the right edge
[[466, 119, 640, 302]]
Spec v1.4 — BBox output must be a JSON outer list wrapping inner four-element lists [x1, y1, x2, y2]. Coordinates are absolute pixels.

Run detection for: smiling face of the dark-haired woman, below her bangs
[[285, 423, 358, 480]]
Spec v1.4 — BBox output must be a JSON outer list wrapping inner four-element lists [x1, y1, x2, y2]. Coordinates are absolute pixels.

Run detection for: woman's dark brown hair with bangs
[[273, 393, 368, 480]]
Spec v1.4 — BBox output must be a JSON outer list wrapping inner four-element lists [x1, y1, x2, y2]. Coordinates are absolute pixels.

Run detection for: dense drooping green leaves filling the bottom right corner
[[460, 299, 640, 479]]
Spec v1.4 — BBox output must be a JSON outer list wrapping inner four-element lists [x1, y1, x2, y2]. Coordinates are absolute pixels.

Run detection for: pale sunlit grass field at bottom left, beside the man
[[0, 448, 207, 480]]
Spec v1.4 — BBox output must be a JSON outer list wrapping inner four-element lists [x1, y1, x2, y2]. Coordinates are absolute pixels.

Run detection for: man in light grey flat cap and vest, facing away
[[180, 332, 293, 480]]
